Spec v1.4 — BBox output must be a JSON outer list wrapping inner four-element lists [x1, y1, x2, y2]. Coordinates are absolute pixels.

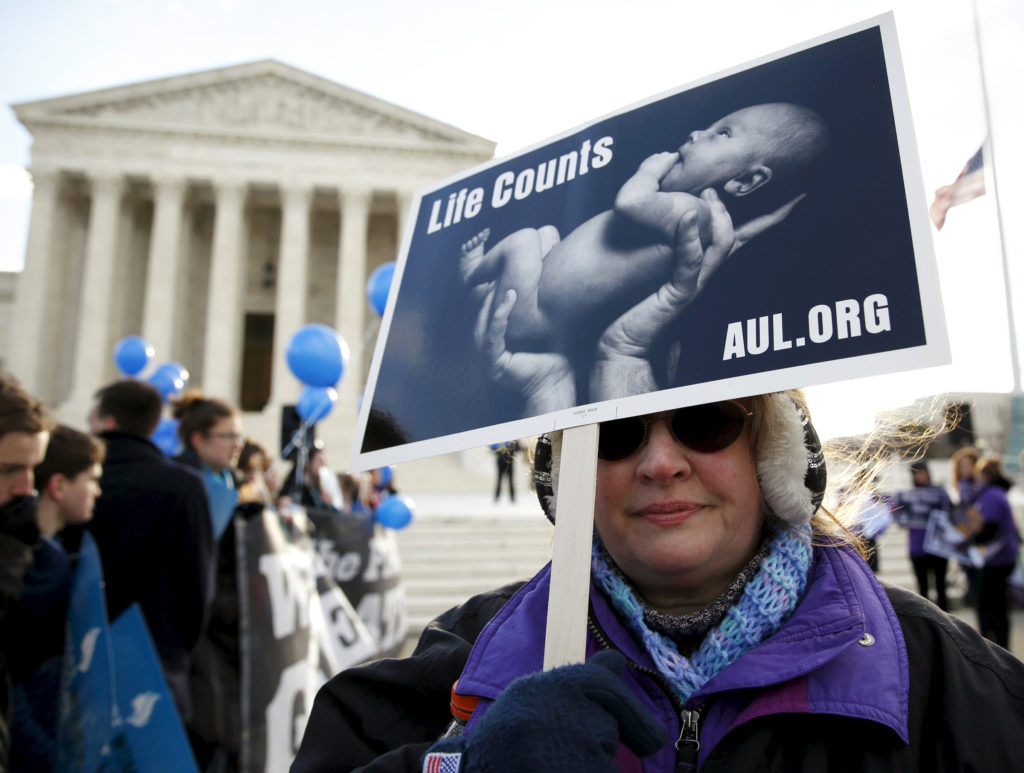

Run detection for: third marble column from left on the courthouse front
[[142, 177, 185, 362]]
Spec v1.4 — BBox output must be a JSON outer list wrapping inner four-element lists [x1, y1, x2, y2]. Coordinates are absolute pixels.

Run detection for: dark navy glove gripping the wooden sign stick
[[424, 650, 666, 773]]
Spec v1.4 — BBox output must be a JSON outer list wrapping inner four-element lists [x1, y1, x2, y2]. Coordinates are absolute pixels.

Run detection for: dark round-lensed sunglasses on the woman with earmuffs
[[597, 400, 754, 462]]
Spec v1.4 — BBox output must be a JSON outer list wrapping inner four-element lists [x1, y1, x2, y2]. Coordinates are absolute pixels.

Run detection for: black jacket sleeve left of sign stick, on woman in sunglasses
[[291, 584, 521, 773]]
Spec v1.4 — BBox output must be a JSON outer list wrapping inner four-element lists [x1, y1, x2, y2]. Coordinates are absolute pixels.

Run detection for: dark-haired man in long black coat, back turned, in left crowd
[[80, 380, 215, 724]]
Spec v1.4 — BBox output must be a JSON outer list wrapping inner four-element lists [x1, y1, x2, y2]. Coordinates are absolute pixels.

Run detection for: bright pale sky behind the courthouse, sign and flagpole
[[0, 0, 1024, 442]]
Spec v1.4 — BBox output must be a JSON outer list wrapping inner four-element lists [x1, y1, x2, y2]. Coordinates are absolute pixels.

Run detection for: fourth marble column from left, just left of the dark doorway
[[202, 180, 248, 403]]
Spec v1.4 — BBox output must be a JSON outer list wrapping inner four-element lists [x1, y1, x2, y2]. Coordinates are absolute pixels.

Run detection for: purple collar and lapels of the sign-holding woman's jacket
[[459, 548, 909, 771]]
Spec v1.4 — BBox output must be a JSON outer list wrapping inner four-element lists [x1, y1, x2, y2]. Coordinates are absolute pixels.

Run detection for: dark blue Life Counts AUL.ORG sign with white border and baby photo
[[356, 18, 945, 462]]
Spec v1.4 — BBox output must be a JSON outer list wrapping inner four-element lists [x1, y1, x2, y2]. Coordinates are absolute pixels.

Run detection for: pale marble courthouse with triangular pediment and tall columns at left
[[5, 60, 495, 467]]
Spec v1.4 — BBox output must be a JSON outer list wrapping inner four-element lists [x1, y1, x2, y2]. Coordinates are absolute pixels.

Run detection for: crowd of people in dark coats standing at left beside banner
[[0, 374, 394, 773]]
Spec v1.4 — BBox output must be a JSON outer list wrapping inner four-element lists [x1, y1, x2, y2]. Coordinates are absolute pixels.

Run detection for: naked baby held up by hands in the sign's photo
[[459, 102, 826, 351]]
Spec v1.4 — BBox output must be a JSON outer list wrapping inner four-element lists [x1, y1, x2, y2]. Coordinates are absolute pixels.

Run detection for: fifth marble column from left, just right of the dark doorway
[[270, 183, 313, 405]]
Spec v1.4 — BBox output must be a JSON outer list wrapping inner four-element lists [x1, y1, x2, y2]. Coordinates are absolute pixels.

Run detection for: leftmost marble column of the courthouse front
[[7, 169, 60, 396]]
